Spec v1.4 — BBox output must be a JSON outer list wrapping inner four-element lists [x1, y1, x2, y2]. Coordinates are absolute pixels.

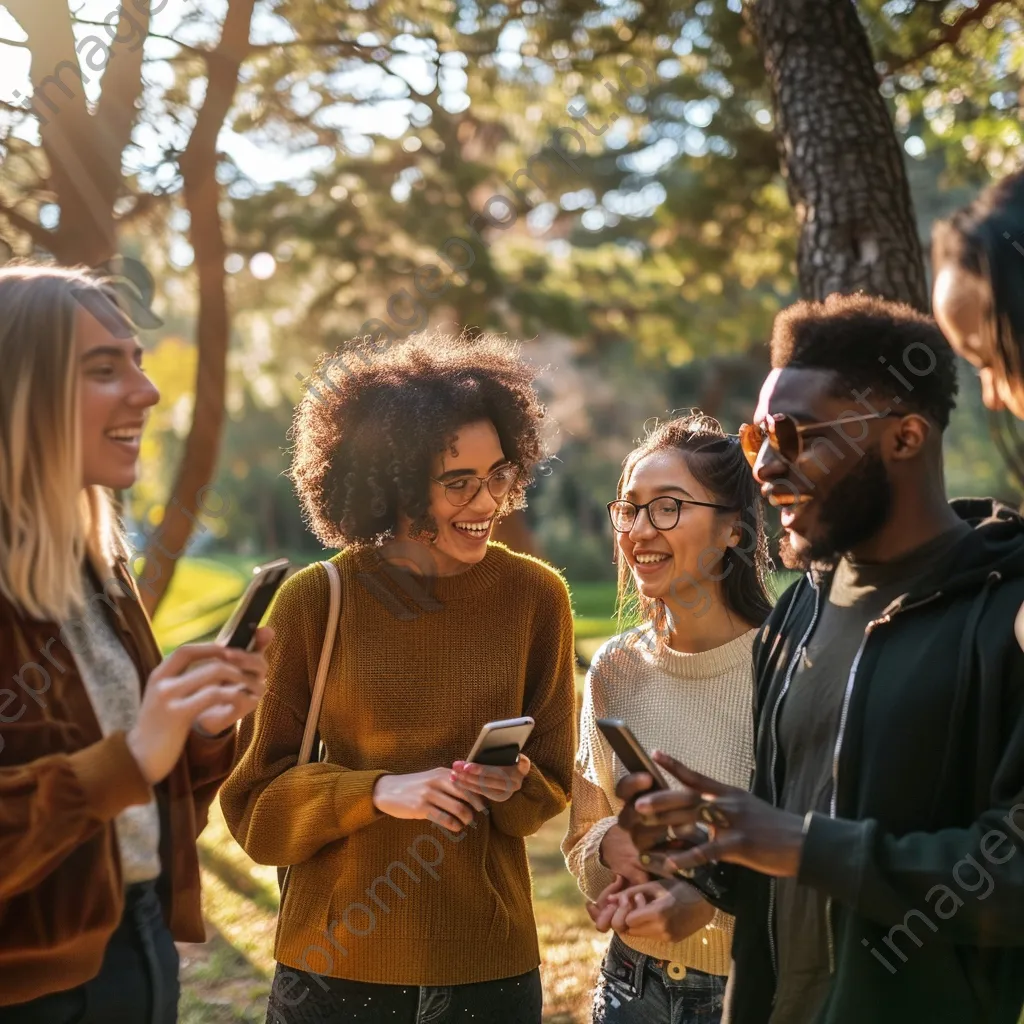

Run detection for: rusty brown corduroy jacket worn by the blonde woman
[[0, 563, 234, 1007]]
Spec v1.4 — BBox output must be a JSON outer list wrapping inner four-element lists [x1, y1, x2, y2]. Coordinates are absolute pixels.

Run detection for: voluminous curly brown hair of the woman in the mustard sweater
[[290, 332, 545, 548]]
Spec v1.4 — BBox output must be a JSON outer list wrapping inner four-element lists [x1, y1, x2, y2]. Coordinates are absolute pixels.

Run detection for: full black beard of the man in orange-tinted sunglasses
[[779, 447, 893, 570]]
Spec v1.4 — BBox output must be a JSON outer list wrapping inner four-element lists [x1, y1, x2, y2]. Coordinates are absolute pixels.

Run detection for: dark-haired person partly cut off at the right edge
[[932, 171, 1024, 471]]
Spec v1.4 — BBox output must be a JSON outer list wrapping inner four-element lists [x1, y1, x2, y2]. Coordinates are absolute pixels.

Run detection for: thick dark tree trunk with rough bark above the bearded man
[[744, 0, 929, 310]]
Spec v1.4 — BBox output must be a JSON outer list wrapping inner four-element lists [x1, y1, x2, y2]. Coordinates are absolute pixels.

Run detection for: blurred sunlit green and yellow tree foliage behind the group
[[0, 0, 1024, 581]]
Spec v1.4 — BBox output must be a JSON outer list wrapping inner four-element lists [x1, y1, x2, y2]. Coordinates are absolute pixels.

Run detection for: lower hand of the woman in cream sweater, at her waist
[[587, 876, 715, 942]]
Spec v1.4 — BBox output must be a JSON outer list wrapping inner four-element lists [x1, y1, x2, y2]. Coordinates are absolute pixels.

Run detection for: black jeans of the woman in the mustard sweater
[[266, 964, 544, 1024]]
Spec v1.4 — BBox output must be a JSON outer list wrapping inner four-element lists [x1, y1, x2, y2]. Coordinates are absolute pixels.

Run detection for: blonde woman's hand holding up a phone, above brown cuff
[[125, 633, 272, 785]]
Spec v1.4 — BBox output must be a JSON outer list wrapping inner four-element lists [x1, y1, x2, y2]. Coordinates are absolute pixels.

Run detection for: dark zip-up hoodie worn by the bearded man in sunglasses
[[721, 499, 1024, 1024]]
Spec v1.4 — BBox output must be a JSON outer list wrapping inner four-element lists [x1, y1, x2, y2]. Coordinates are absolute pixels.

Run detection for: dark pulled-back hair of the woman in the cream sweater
[[615, 409, 772, 633]]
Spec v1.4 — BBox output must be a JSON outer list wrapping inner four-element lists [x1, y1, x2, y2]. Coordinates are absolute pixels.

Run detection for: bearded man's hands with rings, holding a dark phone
[[615, 751, 804, 878]]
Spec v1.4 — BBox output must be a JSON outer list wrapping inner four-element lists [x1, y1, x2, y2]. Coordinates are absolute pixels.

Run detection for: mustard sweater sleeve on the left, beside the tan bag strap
[[220, 565, 384, 866]]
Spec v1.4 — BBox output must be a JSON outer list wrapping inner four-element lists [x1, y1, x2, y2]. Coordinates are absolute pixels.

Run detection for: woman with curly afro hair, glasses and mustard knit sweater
[[221, 334, 575, 1024]]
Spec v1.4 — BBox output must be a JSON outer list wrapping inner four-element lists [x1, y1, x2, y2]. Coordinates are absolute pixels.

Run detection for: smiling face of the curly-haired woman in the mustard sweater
[[407, 420, 515, 575]]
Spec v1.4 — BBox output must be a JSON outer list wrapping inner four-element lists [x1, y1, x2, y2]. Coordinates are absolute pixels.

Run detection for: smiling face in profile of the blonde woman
[[75, 309, 160, 490]]
